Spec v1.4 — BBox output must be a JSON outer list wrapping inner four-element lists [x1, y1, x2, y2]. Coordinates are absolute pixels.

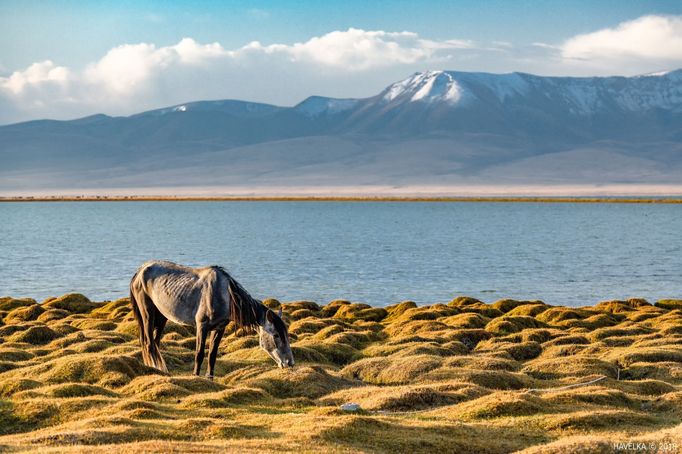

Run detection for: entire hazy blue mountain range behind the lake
[[0, 70, 682, 192]]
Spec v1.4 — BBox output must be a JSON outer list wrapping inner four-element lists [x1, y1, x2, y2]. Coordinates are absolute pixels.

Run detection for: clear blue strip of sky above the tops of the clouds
[[0, 0, 682, 71]]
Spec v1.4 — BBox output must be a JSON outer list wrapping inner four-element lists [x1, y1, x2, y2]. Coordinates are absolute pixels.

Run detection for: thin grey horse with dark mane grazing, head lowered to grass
[[130, 261, 294, 379]]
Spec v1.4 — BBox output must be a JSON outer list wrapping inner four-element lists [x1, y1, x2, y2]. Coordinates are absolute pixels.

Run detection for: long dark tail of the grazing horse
[[130, 271, 168, 372]]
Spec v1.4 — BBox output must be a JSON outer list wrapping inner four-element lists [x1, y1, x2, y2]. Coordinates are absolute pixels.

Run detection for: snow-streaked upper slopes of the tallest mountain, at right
[[380, 70, 682, 115]]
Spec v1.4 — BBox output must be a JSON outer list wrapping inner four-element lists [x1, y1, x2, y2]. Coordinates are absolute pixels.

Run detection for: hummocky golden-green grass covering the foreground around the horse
[[0, 294, 682, 453]]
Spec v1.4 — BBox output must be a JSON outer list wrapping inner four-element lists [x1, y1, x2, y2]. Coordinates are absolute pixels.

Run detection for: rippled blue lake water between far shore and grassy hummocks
[[0, 202, 682, 306]]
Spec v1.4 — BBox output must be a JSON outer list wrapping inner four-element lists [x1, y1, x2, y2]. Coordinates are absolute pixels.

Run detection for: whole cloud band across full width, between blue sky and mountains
[[0, 16, 682, 124]]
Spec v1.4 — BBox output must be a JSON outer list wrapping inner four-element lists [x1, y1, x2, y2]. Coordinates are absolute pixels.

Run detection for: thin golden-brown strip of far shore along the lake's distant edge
[[0, 195, 682, 204]]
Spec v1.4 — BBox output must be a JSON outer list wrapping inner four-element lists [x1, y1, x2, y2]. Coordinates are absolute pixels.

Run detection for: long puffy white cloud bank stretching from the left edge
[[0, 28, 473, 123]]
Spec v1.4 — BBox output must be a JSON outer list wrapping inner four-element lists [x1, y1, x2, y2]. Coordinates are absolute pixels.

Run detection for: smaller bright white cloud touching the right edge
[[560, 16, 682, 66]]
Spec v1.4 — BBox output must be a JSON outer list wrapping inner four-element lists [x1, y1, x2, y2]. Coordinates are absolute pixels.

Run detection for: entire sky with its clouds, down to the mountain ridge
[[0, 0, 682, 124]]
